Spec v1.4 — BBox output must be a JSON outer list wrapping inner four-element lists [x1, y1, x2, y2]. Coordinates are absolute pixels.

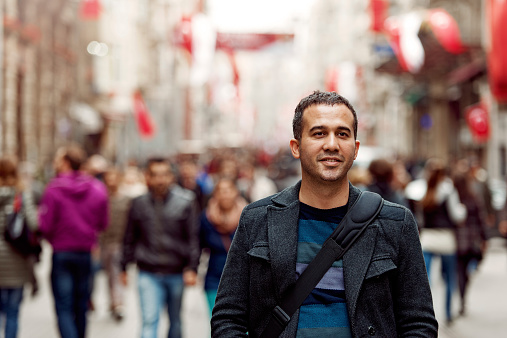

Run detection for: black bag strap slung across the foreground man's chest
[[260, 191, 384, 338]]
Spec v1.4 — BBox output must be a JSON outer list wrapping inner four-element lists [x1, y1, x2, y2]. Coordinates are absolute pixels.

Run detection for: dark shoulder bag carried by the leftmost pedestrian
[[4, 194, 42, 257]]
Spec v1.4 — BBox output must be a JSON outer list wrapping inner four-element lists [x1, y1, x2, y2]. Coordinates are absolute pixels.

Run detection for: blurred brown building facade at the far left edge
[[0, 0, 85, 168]]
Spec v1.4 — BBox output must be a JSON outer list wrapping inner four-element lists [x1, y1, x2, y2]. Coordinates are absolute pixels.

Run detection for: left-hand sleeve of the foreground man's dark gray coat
[[211, 211, 250, 338]]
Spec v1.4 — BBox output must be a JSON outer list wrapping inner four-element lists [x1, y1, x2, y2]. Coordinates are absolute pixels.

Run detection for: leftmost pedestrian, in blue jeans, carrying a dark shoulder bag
[[0, 157, 37, 338]]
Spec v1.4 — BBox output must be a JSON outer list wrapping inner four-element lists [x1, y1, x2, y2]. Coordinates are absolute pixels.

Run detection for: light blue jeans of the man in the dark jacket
[[138, 270, 183, 338]]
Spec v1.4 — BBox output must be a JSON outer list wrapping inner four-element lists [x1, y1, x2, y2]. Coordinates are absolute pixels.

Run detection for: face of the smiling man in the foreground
[[290, 105, 359, 183]]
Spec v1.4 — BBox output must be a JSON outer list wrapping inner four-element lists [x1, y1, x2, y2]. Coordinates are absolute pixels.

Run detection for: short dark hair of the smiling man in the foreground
[[292, 90, 358, 141]]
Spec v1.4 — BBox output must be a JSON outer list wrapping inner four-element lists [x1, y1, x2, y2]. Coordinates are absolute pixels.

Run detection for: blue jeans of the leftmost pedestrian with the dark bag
[[0, 287, 23, 338]]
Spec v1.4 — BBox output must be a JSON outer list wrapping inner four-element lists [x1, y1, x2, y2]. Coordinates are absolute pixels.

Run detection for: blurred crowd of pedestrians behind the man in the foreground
[[0, 145, 507, 338]]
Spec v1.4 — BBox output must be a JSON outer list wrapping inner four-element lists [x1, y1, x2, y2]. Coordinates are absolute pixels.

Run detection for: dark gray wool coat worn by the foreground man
[[211, 182, 438, 337]]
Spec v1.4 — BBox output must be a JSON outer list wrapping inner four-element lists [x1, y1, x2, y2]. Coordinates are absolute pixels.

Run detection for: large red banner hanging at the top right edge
[[486, 0, 507, 102]]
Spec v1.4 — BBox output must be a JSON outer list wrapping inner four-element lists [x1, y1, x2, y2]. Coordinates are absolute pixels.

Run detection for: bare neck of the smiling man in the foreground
[[299, 179, 349, 209]]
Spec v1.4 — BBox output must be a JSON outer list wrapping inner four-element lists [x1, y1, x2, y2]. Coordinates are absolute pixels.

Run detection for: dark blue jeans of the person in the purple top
[[51, 252, 92, 338]]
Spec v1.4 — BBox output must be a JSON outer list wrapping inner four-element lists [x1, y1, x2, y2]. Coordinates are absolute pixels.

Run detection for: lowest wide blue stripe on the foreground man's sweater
[[298, 303, 350, 328]]
